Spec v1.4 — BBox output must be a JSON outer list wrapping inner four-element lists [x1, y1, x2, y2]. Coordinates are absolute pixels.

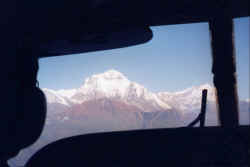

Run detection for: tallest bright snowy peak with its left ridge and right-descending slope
[[43, 70, 172, 112]]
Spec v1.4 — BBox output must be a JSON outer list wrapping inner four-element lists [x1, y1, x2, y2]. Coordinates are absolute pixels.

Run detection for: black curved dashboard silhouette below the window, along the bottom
[[27, 126, 250, 167]]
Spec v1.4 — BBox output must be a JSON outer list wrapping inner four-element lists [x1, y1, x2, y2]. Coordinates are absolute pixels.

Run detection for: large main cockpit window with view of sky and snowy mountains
[[7, 21, 249, 166]]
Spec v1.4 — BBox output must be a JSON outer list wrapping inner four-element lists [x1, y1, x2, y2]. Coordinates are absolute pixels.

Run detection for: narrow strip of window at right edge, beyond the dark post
[[234, 17, 250, 125]]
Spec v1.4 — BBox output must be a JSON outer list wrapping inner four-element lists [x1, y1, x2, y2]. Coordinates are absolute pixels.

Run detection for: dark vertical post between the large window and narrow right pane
[[209, 14, 239, 128]]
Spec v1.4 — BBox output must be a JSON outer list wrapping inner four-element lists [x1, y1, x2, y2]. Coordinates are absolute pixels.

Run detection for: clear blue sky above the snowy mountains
[[38, 17, 249, 99]]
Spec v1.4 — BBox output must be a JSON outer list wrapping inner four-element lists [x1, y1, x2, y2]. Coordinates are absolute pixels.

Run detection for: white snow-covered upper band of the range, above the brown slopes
[[43, 69, 215, 112]]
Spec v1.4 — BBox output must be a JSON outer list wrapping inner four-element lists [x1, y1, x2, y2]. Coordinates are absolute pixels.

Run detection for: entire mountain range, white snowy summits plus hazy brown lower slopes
[[38, 70, 249, 129]]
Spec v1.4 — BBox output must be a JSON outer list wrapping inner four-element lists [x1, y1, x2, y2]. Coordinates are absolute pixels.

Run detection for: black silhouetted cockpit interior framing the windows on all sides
[[0, 0, 250, 167]]
